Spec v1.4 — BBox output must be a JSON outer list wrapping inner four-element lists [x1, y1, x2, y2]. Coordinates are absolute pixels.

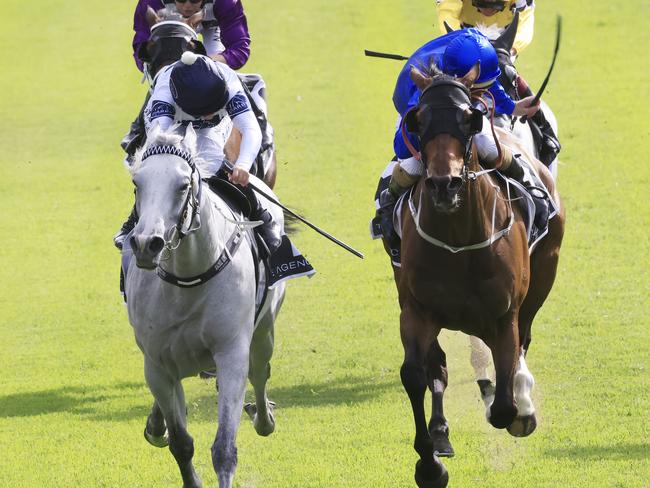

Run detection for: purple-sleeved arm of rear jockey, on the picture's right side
[[213, 0, 251, 69]]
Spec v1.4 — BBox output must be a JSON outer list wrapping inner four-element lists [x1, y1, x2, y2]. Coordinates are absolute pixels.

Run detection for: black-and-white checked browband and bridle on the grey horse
[[142, 146, 202, 246]]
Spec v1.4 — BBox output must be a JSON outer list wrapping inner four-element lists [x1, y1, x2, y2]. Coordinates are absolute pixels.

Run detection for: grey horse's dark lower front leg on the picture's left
[[144, 356, 202, 488]]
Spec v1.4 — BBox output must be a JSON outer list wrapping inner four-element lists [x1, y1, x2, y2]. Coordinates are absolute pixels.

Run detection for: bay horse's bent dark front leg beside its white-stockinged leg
[[487, 310, 519, 429]]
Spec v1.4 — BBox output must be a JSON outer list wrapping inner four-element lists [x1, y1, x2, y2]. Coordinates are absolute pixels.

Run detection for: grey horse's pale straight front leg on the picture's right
[[212, 332, 250, 488]]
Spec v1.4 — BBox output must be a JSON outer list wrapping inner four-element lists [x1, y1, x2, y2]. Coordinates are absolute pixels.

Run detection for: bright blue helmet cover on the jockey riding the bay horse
[[440, 31, 501, 88]]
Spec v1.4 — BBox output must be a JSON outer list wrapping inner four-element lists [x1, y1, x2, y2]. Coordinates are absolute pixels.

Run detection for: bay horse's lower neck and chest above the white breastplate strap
[[414, 175, 508, 247]]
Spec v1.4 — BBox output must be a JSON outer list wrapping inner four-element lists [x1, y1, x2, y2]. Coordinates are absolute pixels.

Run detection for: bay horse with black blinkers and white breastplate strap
[[385, 65, 565, 488]]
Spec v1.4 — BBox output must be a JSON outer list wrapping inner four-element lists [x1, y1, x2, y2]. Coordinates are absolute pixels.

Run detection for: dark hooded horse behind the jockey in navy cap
[[123, 7, 277, 188]]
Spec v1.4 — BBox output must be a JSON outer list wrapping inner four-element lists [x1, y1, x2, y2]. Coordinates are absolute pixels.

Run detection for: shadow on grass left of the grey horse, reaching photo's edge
[[0, 382, 150, 420]]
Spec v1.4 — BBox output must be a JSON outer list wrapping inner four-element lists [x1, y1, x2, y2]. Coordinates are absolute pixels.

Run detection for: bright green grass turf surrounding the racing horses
[[0, 0, 650, 488]]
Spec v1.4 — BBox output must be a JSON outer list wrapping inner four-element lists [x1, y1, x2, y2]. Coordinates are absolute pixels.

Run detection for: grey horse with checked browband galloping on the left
[[124, 125, 284, 488]]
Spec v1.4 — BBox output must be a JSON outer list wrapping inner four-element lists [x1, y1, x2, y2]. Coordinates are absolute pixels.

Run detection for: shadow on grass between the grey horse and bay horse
[[190, 375, 402, 420]]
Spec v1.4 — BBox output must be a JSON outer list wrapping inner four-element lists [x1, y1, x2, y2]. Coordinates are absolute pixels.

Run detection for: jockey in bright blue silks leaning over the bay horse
[[379, 28, 548, 241]]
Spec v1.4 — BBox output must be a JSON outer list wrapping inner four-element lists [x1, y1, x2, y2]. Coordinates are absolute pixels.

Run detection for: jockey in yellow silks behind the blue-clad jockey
[[436, 0, 535, 55]]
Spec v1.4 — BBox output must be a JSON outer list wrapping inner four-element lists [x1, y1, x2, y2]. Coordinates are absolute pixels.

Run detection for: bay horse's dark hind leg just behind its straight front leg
[[427, 339, 454, 457]]
